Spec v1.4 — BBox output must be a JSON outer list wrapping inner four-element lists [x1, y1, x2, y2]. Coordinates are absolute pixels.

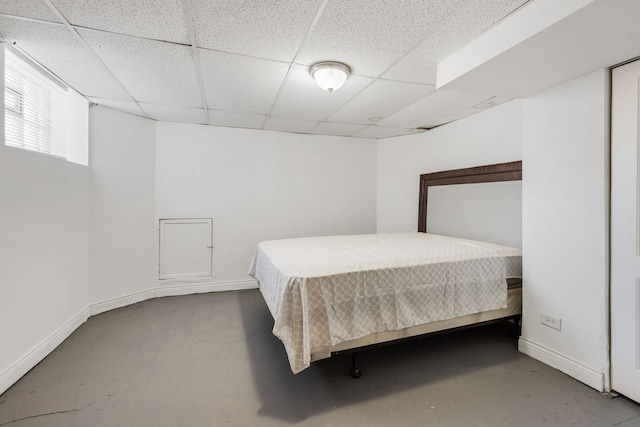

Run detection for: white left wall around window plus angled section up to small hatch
[[0, 107, 156, 392]]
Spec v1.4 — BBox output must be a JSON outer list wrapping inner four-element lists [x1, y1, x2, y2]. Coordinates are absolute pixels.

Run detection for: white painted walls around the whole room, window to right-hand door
[[0, 71, 609, 398]]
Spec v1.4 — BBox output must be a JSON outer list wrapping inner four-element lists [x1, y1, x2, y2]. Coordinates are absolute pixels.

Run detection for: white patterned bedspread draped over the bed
[[249, 233, 521, 373]]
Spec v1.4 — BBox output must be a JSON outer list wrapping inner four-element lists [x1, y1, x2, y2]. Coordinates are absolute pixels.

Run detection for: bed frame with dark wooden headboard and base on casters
[[311, 161, 522, 378]]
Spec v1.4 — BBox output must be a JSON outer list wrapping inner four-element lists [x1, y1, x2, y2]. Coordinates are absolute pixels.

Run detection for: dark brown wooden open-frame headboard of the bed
[[418, 161, 522, 233]]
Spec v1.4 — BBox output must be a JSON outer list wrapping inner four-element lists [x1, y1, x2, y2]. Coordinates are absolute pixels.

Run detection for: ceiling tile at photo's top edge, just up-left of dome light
[[191, 0, 322, 61]]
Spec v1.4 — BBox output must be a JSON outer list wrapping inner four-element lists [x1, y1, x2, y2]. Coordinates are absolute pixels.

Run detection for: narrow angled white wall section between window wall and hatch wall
[[89, 107, 157, 303]]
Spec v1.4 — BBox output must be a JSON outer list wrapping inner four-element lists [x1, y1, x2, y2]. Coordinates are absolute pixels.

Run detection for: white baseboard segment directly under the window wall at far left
[[0, 308, 90, 394]]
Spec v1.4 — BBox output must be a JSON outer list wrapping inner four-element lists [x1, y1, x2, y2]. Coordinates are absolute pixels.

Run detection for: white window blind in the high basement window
[[4, 49, 67, 159]]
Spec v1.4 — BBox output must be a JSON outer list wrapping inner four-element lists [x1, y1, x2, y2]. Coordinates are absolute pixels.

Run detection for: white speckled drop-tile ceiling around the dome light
[[0, 0, 528, 138]]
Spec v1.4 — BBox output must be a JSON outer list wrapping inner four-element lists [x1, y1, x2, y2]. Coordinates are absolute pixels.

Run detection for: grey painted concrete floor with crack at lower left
[[0, 290, 640, 427]]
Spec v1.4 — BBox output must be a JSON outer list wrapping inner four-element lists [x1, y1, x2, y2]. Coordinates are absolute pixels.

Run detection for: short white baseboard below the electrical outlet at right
[[518, 337, 604, 392]]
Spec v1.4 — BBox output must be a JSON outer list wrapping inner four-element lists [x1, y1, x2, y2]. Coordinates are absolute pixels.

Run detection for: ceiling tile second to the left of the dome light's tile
[[79, 30, 203, 107]]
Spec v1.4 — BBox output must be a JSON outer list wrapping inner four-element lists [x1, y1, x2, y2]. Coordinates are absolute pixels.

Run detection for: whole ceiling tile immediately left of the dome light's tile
[[198, 49, 289, 114]]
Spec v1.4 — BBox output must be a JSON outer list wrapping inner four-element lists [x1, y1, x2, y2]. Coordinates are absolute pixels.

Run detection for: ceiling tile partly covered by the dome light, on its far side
[[271, 65, 373, 121]]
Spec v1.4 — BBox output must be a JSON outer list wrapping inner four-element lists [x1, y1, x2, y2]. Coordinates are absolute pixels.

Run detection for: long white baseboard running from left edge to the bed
[[0, 280, 258, 394]]
